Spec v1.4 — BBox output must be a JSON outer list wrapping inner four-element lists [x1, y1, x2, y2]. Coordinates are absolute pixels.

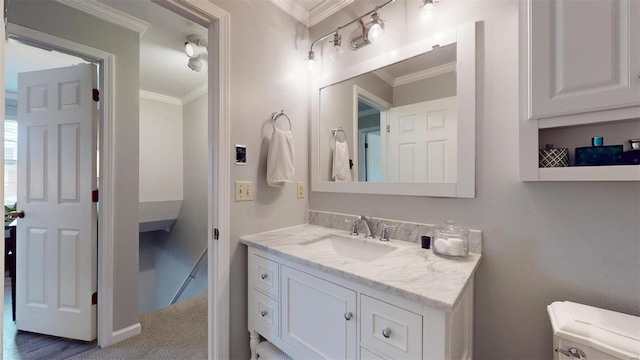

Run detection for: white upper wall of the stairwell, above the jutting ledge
[[139, 97, 183, 202]]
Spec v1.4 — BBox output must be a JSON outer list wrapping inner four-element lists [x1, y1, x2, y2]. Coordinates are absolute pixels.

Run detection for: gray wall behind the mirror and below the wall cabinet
[[310, 1, 640, 359]]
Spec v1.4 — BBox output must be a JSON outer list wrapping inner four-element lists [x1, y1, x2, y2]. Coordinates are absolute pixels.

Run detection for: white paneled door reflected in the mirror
[[387, 96, 458, 183]]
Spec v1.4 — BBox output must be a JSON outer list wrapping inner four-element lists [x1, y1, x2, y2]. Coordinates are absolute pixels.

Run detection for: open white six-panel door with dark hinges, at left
[[16, 64, 98, 341]]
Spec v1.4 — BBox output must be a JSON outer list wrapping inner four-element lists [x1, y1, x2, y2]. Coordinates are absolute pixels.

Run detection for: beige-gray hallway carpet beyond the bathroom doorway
[[69, 294, 207, 360]]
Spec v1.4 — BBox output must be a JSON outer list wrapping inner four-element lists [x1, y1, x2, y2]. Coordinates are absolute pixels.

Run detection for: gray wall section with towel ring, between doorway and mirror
[[208, 1, 310, 359]]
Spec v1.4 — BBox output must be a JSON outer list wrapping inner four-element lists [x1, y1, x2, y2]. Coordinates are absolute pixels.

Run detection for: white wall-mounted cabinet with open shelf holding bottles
[[519, 0, 640, 181]]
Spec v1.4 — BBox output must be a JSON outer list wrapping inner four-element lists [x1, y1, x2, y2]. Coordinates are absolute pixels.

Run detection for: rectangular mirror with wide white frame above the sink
[[312, 23, 476, 198]]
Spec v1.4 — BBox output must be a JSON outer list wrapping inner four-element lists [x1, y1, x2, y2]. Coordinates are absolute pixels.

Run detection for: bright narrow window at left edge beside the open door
[[4, 118, 18, 205]]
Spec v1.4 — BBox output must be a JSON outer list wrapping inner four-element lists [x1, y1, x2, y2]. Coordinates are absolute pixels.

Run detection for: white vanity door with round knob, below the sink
[[280, 266, 357, 359]]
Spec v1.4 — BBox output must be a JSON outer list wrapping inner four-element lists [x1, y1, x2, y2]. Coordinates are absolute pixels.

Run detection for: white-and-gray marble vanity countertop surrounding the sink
[[240, 224, 481, 311]]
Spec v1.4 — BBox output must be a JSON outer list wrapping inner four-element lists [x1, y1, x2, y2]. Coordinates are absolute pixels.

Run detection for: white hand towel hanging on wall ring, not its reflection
[[267, 127, 295, 187]]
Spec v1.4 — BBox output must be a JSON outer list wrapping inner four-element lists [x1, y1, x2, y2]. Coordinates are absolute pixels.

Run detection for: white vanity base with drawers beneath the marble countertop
[[248, 246, 473, 359]]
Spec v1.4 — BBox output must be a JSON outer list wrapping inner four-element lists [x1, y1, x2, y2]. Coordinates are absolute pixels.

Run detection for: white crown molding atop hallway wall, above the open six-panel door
[[56, 0, 151, 36]]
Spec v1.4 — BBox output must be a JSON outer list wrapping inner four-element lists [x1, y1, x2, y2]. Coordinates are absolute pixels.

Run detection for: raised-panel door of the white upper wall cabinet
[[529, 0, 640, 118]]
